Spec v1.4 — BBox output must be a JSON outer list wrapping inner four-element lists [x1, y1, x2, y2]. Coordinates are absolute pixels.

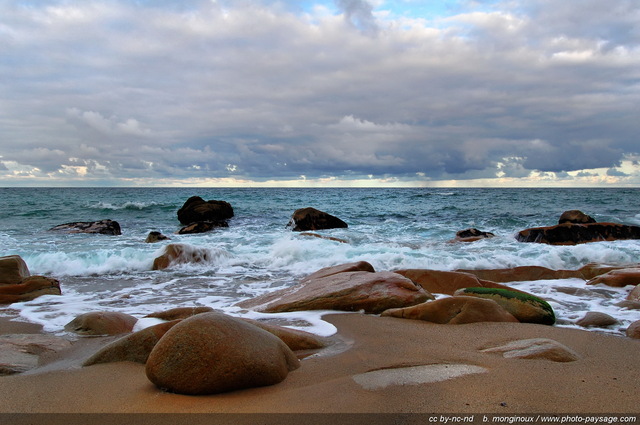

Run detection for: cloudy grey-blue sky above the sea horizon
[[0, 0, 640, 187]]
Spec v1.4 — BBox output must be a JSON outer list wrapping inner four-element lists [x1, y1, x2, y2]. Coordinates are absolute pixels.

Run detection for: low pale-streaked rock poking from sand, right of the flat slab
[[482, 338, 580, 362]]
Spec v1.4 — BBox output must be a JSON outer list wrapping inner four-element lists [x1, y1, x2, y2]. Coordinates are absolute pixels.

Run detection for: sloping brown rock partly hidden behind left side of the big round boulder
[[82, 320, 180, 366]]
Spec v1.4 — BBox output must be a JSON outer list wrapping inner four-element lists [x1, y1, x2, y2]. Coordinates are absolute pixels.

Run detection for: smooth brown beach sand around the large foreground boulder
[[0, 314, 640, 425]]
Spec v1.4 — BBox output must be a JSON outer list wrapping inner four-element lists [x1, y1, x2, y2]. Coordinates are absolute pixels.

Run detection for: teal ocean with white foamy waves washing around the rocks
[[0, 188, 640, 335]]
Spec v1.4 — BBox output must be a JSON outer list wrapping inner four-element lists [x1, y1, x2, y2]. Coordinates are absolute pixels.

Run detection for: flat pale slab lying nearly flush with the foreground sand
[[353, 364, 489, 390]]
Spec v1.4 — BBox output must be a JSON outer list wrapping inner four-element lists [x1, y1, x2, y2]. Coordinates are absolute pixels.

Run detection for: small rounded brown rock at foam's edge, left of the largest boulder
[[64, 311, 138, 335]]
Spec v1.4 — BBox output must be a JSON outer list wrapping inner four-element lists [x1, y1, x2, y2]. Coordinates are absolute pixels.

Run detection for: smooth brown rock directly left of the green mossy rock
[[381, 296, 518, 325]]
